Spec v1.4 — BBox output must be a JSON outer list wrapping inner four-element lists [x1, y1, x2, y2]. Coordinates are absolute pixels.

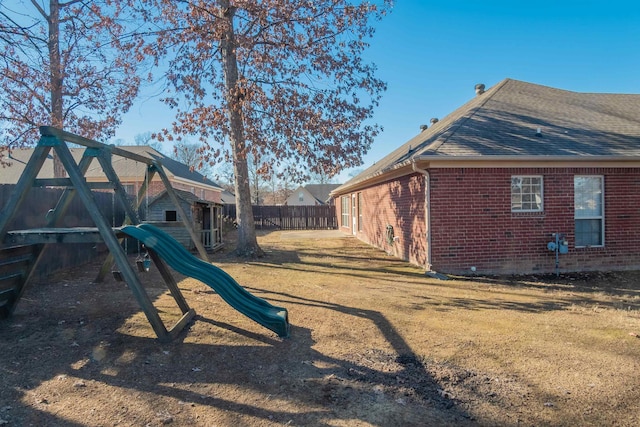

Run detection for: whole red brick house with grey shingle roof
[[332, 79, 640, 275]]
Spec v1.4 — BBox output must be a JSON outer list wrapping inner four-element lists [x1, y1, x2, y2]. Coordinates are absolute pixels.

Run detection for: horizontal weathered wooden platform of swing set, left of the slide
[[4, 227, 124, 246]]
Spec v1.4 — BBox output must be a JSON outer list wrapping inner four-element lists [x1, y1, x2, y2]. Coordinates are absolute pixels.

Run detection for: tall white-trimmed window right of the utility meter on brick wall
[[573, 175, 604, 247]]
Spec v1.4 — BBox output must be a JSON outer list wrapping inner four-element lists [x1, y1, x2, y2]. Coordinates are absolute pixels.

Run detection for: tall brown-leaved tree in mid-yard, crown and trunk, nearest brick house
[[142, 0, 391, 256]]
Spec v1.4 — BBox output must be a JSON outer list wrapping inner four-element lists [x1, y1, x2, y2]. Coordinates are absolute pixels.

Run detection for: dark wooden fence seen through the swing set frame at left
[[0, 184, 124, 278]]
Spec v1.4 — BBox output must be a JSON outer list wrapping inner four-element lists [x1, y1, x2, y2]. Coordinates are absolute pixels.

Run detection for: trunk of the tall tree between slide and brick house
[[220, 0, 264, 257]]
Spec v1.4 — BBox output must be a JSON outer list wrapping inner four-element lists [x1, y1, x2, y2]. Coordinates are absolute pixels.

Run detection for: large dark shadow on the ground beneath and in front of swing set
[[0, 258, 473, 426]]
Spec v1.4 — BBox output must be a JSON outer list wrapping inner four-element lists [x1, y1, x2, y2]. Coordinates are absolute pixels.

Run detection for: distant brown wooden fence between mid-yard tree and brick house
[[224, 205, 338, 230]]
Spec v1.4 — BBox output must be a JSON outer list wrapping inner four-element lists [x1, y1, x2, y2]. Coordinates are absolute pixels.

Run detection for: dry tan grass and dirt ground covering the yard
[[0, 232, 640, 426]]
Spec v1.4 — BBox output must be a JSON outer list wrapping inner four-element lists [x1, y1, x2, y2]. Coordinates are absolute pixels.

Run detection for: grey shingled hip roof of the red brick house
[[334, 79, 640, 194]]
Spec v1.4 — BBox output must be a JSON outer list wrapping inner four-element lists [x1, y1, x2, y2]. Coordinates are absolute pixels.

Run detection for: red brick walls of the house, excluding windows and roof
[[336, 168, 640, 274]]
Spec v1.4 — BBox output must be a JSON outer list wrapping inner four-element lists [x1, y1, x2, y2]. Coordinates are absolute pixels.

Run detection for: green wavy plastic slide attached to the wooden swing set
[[122, 224, 289, 337]]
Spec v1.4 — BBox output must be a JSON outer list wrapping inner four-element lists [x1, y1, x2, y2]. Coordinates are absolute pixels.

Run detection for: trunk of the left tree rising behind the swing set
[[48, 0, 65, 178]]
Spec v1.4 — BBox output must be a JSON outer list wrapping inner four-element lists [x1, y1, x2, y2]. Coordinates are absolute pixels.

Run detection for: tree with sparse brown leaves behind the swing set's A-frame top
[[0, 0, 149, 172]]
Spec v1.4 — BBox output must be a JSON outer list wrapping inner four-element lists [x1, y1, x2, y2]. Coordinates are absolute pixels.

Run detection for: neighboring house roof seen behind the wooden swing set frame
[[0, 145, 221, 189]]
